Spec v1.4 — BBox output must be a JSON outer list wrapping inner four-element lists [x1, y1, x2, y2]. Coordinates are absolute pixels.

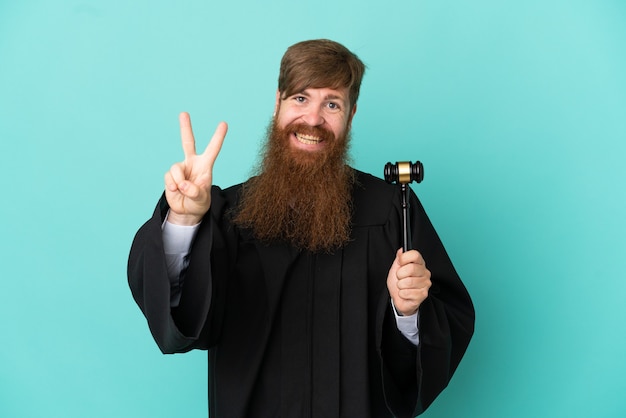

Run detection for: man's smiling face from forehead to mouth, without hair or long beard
[[275, 88, 356, 157]]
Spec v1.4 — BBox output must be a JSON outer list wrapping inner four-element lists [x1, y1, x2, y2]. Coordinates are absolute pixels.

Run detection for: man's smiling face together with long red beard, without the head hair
[[229, 88, 355, 252]]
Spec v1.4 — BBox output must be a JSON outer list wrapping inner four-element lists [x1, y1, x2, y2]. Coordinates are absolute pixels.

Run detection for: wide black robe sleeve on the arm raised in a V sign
[[128, 189, 228, 353]]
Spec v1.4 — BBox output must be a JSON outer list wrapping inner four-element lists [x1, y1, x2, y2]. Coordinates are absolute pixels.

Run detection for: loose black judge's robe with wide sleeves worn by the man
[[128, 172, 474, 418]]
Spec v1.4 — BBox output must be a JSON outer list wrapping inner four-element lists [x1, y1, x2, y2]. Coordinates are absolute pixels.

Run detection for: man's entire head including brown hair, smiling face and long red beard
[[233, 39, 365, 252]]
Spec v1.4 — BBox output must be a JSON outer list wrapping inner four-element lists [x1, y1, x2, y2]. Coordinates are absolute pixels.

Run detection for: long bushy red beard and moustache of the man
[[234, 121, 354, 252]]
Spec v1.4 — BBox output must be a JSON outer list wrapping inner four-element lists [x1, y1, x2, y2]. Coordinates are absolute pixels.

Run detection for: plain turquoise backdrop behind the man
[[0, 0, 626, 418]]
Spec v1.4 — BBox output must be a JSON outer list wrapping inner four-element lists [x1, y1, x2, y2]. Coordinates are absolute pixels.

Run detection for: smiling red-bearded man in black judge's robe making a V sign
[[128, 40, 474, 418]]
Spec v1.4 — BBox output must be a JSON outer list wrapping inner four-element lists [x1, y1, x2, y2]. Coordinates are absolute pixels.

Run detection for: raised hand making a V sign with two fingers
[[165, 112, 228, 225]]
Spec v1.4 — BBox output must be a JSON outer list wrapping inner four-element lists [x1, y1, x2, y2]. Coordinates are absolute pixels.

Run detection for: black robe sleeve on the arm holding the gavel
[[379, 189, 474, 417]]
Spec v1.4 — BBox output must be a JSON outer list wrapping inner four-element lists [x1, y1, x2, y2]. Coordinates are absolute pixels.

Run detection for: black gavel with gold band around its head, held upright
[[385, 161, 424, 252]]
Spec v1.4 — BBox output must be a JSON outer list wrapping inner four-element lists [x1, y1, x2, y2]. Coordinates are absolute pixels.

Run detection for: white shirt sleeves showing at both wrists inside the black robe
[[163, 220, 419, 345]]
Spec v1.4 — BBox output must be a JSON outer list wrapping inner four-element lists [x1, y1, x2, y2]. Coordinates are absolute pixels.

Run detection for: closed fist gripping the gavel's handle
[[387, 249, 432, 316]]
